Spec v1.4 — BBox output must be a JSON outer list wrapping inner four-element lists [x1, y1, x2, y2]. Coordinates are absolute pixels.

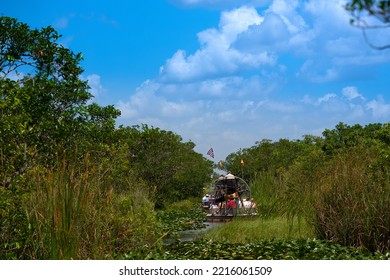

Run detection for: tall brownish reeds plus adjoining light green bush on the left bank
[[24, 152, 159, 259]]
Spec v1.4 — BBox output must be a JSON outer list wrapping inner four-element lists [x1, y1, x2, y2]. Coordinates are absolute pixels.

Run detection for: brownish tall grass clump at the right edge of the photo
[[314, 149, 390, 252]]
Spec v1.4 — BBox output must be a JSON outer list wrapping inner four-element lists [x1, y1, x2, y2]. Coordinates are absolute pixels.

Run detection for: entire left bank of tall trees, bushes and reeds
[[0, 16, 213, 259]]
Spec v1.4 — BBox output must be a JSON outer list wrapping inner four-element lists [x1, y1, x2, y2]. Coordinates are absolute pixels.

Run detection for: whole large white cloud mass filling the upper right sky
[[160, 0, 390, 83]]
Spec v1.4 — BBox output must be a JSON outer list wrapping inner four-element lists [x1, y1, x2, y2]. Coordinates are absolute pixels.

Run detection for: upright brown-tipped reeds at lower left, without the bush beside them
[[26, 154, 111, 259]]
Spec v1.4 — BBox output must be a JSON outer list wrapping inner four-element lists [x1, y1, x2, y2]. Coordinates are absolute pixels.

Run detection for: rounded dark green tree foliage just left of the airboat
[[115, 125, 213, 208]]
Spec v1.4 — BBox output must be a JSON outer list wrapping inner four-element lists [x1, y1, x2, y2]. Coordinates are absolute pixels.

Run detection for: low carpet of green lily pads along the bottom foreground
[[139, 239, 390, 260]]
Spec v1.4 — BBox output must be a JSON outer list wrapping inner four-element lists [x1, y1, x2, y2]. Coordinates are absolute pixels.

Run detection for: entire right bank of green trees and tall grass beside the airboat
[[224, 123, 390, 252]]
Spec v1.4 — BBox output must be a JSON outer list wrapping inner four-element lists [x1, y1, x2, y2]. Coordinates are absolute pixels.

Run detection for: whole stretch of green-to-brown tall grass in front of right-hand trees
[[245, 147, 390, 251]]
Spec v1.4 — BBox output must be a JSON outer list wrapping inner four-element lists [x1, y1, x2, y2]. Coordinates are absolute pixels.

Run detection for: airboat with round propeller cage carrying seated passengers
[[202, 173, 258, 222]]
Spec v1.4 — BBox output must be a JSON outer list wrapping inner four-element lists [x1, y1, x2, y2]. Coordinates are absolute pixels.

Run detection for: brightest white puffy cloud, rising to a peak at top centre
[[160, 7, 275, 82]]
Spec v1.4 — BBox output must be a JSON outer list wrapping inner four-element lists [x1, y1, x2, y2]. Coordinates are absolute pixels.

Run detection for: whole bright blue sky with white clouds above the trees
[[0, 0, 390, 162]]
